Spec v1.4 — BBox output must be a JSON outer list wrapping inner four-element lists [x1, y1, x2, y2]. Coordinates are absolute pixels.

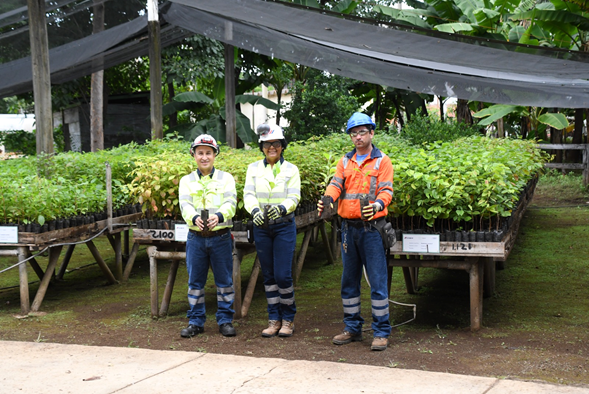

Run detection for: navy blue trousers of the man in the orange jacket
[[341, 220, 391, 337]]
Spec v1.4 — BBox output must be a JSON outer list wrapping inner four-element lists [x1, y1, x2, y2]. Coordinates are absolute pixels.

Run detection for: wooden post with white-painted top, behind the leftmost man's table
[[147, 0, 164, 139]]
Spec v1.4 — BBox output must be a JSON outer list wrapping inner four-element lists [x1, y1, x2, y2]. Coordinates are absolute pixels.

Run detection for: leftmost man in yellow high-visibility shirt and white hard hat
[[179, 134, 237, 338]]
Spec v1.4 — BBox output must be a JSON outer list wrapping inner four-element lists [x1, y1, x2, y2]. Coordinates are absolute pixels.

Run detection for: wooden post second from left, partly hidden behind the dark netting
[[90, 0, 104, 152]]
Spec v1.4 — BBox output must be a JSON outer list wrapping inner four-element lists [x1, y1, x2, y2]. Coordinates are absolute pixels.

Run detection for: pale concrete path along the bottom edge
[[0, 341, 589, 394]]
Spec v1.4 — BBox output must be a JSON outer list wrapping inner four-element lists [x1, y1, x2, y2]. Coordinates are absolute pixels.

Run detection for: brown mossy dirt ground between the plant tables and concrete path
[[0, 190, 589, 388]]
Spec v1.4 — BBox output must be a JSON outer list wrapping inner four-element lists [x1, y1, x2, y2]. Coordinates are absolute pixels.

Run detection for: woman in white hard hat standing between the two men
[[243, 124, 301, 338]]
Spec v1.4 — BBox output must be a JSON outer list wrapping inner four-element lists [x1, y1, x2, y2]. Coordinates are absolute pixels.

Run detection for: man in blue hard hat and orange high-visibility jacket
[[317, 112, 393, 351]]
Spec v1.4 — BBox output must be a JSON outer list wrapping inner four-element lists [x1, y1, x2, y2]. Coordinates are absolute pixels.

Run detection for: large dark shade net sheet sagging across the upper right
[[163, 0, 589, 108]]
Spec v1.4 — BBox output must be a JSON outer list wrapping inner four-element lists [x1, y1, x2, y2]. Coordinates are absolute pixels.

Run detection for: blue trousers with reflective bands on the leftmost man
[[186, 232, 235, 327]]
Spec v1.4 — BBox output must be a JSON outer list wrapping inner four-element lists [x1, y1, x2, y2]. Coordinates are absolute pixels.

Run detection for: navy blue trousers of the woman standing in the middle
[[254, 220, 297, 321]]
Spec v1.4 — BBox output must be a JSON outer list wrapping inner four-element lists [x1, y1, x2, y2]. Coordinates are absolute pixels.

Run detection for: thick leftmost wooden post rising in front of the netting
[[27, 0, 53, 155]]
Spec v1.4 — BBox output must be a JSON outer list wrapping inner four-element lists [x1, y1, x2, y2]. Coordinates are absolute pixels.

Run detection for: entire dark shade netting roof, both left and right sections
[[0, 0, 589, 108]]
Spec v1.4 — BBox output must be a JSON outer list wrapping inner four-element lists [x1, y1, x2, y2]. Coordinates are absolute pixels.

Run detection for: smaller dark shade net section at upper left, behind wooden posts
[[0, 0, 188, 97]]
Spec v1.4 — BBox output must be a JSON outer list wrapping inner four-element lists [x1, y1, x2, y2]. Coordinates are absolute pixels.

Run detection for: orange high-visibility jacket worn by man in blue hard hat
[[325, 145, 393, 219]]
